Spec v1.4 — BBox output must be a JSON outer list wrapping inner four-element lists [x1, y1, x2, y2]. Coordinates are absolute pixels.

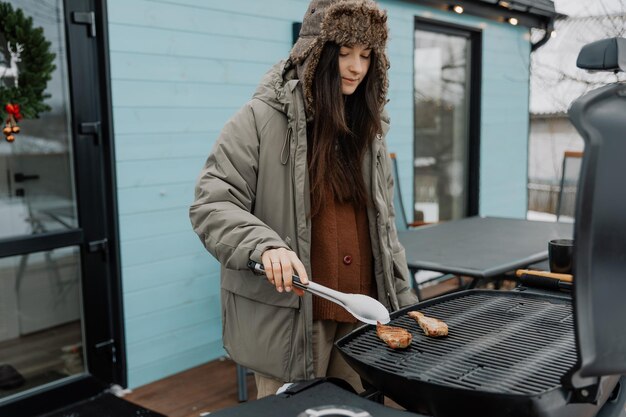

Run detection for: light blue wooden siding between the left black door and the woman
[[108, 0, 307, 387]]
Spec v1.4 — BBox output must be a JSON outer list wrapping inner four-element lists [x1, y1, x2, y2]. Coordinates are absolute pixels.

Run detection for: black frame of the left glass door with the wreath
[[0, 0, 127, 416]]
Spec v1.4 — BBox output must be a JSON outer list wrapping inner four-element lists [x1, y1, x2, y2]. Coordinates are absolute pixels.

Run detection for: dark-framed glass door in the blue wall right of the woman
[[414, 19, 481, 222]]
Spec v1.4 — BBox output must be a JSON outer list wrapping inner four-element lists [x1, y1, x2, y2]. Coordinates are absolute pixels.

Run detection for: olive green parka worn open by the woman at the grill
[[190, 62, 417, 382]]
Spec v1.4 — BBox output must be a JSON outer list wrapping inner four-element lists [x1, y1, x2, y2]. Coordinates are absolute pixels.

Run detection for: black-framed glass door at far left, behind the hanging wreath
[[0, 0, 125, 415]]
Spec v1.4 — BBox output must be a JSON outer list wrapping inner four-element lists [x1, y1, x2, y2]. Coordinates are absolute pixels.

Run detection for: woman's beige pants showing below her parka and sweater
[[254, 320, 363, 398]]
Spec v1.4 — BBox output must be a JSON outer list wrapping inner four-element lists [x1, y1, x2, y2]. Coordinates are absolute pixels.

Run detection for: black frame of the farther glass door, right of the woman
[[413, 16, 483, 217]]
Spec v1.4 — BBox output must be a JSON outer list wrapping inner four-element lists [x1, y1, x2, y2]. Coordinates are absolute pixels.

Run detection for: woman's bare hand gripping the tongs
[[261, 248, 309, 296]]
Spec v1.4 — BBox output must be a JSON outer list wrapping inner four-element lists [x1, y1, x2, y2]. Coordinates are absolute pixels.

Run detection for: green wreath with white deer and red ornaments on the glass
[[0, 2, 56, 142]]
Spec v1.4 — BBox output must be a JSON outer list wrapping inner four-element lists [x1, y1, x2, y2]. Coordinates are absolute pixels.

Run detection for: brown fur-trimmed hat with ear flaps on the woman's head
[[287, 0, 389, 119]]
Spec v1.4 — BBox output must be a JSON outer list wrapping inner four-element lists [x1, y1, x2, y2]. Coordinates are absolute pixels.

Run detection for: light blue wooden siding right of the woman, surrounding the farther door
[[379, 0, 530, 219]]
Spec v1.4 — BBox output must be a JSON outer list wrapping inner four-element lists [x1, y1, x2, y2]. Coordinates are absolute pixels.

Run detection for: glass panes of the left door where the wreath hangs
[[0, 0, 85, 398]]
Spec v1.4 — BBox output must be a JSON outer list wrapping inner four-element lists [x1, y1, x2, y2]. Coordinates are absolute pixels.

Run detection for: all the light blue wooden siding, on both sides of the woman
[[108, 0, 529, 387]]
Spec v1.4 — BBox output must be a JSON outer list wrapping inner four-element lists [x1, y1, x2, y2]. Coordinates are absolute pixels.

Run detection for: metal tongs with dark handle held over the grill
[[248, 261, 391, 324]]
